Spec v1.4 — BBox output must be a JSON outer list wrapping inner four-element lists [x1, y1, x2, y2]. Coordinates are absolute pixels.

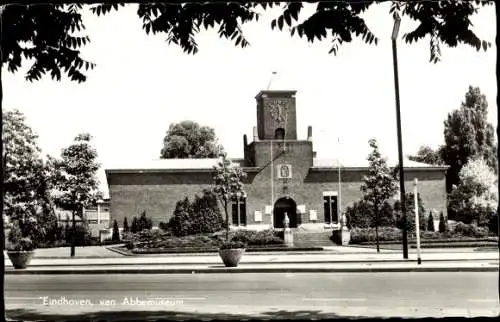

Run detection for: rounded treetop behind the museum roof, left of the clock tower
[[161, 121, 223, 159]]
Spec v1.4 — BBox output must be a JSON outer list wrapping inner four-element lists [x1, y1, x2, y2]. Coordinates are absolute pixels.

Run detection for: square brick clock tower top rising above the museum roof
[[255, 90, 297, 140]]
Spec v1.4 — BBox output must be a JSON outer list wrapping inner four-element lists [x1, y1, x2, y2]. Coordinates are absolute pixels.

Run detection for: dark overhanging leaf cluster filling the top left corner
[[1, 4, 95, 82]]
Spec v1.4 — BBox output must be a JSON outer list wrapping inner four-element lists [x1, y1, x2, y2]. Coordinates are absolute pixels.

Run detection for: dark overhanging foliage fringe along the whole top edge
[[0, 0, 493, 82]]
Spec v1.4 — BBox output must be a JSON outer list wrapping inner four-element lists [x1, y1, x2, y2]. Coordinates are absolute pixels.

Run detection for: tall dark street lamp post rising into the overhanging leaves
[[391, 15, 408, 259]]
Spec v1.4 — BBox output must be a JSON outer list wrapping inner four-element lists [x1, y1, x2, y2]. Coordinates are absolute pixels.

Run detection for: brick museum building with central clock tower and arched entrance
[[106, 90, 447, 231]]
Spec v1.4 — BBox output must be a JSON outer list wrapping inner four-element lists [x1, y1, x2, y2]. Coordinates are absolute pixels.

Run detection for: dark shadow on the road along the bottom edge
[[6, 309, 346, 322]]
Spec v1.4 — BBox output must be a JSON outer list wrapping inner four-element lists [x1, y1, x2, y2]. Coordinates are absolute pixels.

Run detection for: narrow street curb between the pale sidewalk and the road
[[5, 266, 499, 275]]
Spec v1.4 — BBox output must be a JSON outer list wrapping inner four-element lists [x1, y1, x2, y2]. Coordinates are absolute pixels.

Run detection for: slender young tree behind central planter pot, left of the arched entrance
[[213, 153, 247, 242]]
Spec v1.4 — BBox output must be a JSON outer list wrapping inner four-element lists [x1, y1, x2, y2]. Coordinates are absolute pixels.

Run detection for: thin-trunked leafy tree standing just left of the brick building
[[49, 133, 99, 256]]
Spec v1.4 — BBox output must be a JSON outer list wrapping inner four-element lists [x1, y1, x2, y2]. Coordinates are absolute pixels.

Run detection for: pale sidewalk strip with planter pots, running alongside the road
[[5, 248, 499, 274]]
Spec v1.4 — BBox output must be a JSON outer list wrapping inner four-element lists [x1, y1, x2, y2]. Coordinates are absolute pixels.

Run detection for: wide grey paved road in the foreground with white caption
[[4, 272, 499, 320]]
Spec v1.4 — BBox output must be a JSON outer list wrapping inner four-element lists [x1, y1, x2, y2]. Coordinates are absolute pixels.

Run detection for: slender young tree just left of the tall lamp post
[[361, 139, 398, 252]]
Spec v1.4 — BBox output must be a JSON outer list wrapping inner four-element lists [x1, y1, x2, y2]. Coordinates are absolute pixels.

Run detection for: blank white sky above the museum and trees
[[2, 4, 497, 197]]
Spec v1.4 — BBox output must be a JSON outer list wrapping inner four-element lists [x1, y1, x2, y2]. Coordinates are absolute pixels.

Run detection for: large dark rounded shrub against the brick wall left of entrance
[[166, 190, 224, 237]]
